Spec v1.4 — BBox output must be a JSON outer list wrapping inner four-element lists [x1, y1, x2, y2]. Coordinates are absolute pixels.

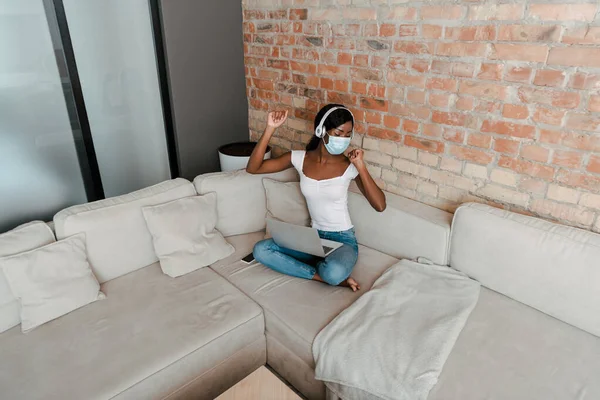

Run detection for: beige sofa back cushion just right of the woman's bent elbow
[[348, 187, 452, 265]]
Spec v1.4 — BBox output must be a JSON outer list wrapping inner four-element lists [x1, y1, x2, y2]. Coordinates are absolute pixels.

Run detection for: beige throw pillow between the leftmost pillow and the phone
[[142, 193, 235, 278]]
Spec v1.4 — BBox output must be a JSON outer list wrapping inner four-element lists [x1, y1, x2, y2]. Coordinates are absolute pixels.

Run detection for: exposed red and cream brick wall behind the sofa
[[243, 0, 600, 232]]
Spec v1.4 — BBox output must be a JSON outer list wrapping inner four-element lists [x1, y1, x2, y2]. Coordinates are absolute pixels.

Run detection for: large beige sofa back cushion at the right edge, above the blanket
[[450, 204, 600, 336]]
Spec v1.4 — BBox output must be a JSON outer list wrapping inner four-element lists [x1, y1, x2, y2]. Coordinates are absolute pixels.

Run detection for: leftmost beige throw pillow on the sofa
[[0, 234, 104, 332]]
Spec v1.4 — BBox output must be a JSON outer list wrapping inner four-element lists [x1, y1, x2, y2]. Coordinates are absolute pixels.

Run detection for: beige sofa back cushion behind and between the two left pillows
[[54, 178, 196, 283]]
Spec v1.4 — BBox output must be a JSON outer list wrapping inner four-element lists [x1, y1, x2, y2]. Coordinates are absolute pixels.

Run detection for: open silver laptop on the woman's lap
[[267, 219, 343, 257]]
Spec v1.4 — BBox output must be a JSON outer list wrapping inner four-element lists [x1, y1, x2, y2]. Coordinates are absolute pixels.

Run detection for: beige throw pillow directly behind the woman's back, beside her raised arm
[[263, 179, 310, 238]]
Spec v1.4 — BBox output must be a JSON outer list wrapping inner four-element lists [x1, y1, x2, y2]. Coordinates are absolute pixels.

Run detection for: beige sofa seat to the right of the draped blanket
[[428, 288, 600, 400]]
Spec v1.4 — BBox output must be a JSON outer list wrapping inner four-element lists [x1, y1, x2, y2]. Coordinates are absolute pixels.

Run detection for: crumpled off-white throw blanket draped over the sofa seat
[[313, 260, 480, 400]]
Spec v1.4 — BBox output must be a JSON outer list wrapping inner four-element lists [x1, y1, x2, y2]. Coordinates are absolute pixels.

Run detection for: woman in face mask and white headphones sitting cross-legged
[[246, 104, 386, 291]]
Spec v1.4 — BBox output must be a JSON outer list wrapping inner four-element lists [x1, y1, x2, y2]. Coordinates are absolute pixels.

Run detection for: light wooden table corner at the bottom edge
[[216, 366, 301, 400]]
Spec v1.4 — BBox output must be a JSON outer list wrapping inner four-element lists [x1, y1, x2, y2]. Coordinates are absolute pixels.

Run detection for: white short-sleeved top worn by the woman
[[292, 150, 358, 232]]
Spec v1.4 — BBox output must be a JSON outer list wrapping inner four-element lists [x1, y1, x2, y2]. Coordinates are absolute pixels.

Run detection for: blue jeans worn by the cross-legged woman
[[254, 229, 358, 286]]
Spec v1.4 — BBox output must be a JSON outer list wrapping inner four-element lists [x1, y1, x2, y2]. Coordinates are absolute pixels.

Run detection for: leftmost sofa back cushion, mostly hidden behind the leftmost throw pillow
[[0, 221, 55, 333]]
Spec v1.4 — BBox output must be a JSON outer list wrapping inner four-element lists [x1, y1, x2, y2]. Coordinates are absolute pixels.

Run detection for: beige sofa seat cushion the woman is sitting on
[[211, 234, 398, 368]]
